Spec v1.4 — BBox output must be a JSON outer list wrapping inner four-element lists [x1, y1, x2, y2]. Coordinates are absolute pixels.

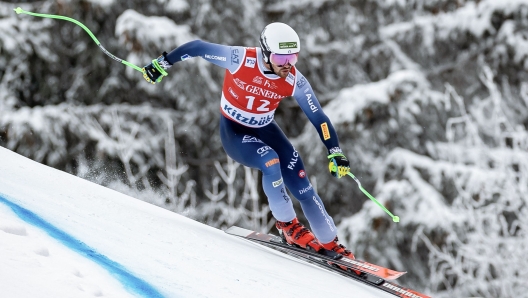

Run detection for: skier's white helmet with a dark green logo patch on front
[[260, 22, 301, 63]]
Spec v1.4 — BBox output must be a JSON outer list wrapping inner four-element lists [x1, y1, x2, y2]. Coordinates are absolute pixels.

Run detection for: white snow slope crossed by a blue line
[[0, 147, 392, 298]]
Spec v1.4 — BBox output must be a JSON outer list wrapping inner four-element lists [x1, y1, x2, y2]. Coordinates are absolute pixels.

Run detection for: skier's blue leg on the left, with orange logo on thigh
[[220, 117, 296, 222]]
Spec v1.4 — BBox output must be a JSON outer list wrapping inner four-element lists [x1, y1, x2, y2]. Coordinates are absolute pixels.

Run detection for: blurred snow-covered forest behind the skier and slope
[[0, 0, 528, 297]]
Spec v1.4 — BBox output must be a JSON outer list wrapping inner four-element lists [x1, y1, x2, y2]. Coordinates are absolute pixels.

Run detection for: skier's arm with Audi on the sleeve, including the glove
[[293, 71, 350, 178]]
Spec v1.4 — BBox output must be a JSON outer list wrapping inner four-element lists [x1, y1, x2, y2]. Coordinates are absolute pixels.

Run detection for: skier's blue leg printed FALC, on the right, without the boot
[[259, 122, 337, 243]]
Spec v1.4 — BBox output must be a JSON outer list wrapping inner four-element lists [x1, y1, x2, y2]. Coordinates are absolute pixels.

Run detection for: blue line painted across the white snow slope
[[0, 194, 163, 298]]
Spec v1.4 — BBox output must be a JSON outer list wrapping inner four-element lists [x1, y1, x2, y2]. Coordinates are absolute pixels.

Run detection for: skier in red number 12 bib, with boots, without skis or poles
[[143, 23, 354, 259]]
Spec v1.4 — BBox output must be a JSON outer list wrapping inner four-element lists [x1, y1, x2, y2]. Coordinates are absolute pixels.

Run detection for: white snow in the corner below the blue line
[[0, 199, 132, 298]]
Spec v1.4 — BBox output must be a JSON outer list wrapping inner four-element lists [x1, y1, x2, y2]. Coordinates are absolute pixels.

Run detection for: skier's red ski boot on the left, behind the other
[[275, 217, 324, 252]]
